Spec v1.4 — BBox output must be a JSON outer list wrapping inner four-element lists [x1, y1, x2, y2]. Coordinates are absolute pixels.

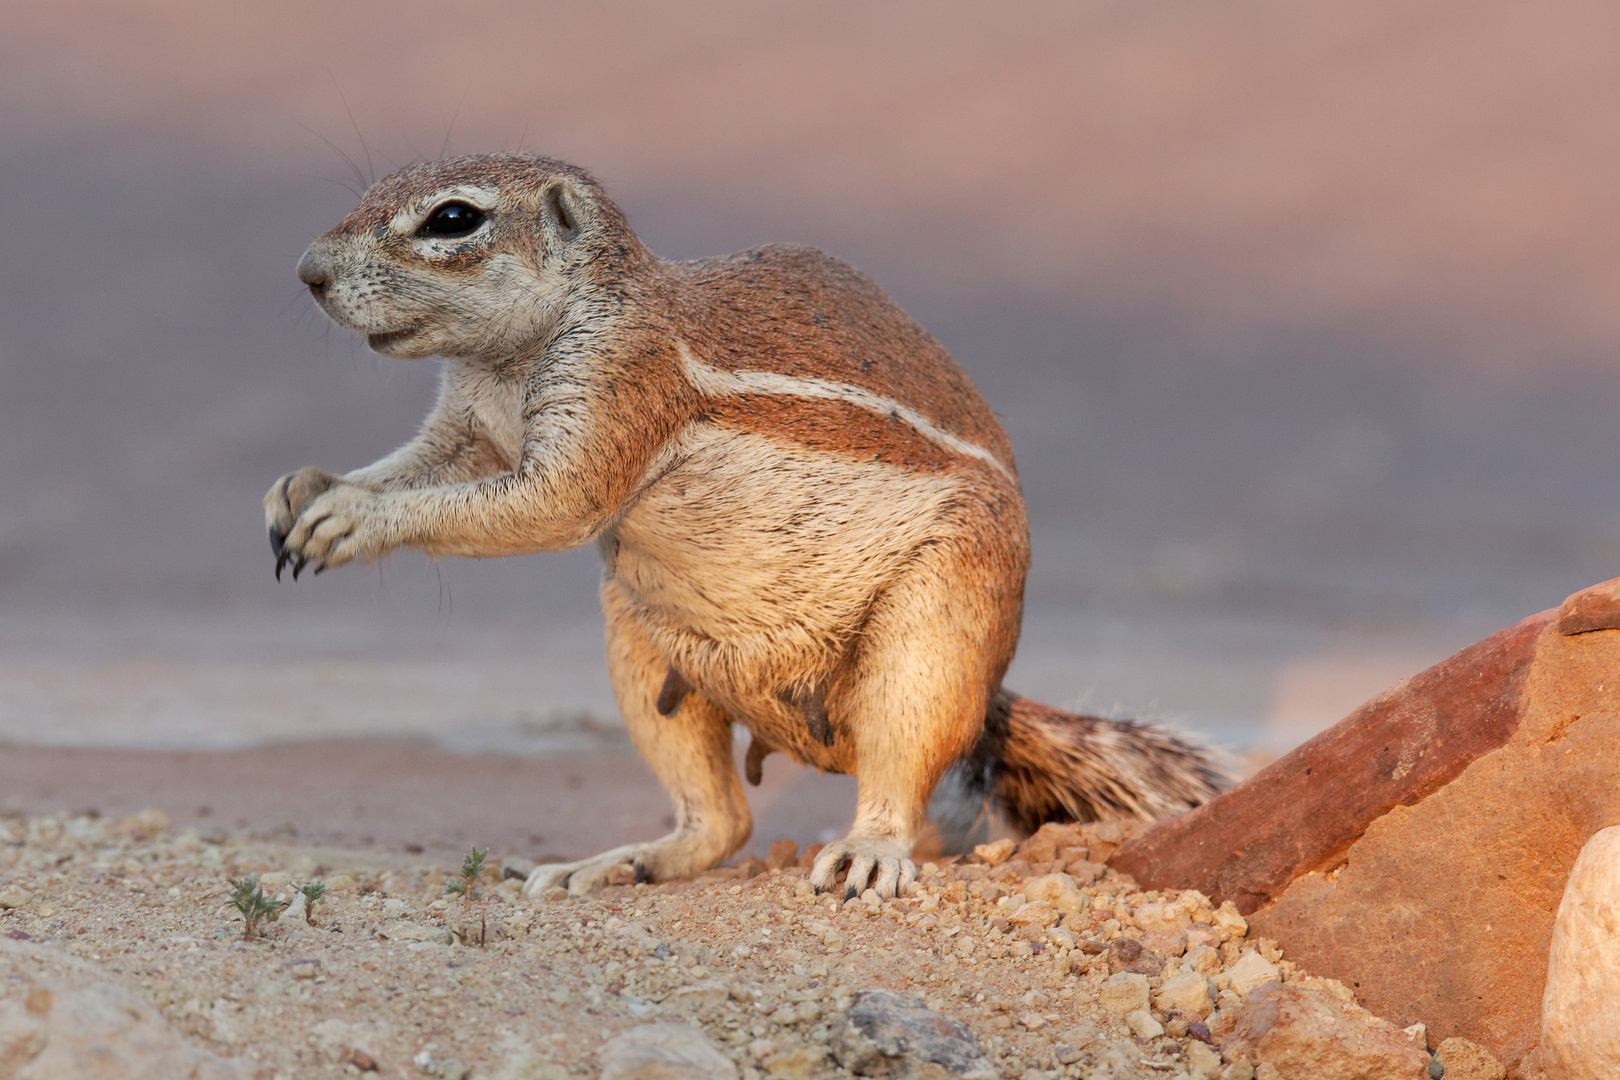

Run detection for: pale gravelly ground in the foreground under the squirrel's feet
[[0, 811, 1458, 1080]]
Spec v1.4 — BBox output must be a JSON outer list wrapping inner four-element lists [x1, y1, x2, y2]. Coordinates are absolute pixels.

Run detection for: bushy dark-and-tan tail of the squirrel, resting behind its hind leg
[[962, 690, 1231, 832]]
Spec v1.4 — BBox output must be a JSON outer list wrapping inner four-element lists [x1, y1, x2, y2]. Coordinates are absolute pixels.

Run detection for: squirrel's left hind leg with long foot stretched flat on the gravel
[[523, 580, 753, 897]]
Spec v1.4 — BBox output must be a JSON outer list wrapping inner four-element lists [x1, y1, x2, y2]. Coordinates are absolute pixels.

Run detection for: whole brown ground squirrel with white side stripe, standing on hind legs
[[264, 154, 1223, 895]]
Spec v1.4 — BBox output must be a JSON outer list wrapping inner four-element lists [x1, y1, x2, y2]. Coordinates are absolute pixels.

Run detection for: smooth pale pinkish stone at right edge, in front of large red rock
[[1541, 826, 1620, 1080]]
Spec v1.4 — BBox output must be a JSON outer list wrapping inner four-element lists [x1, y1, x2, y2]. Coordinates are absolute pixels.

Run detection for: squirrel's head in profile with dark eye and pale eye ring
[[298, 154, 642, 358]]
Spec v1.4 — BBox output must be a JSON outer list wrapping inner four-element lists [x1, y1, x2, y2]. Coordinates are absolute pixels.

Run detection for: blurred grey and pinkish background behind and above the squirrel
[[0, 0, 1620, 751]]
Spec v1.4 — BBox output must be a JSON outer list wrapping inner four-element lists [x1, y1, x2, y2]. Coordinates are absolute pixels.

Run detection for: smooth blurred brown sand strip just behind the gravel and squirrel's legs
[[0, 738, 855, 861]]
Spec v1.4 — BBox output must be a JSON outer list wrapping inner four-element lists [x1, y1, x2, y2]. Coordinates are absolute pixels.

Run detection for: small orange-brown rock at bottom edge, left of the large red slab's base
[[1221, 983, 1429, 1080]]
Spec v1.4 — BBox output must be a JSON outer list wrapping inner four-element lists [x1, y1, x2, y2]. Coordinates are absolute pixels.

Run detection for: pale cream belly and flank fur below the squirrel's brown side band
[[601, 427, 956, 767]]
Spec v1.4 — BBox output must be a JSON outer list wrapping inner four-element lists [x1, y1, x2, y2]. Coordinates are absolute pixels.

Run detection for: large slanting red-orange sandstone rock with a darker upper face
[[1113, 581, 1620, 1078]]
